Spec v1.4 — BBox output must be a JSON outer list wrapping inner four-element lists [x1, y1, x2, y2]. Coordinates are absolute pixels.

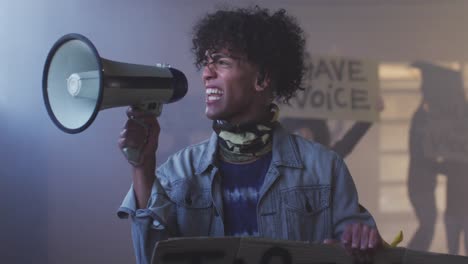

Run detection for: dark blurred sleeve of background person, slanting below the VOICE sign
[[331, 122, 372, 158]]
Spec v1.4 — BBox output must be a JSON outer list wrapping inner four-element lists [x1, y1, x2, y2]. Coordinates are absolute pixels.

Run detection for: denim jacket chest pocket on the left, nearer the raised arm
[[172, 181, 213, 236]]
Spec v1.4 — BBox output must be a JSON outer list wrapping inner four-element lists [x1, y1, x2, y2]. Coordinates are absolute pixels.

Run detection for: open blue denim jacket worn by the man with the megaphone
[[118, 124, 375, 263]]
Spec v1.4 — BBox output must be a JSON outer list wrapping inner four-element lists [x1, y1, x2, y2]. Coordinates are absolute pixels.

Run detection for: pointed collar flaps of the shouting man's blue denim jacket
[[195, 123, 303, 175]]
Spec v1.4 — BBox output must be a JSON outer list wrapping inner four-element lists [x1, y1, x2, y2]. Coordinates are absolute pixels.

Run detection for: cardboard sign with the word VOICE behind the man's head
[[280, 55, 379, 121]]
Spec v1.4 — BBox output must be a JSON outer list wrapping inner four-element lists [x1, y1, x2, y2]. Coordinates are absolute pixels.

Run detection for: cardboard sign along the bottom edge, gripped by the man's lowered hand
[[152, 237, 468, 264]]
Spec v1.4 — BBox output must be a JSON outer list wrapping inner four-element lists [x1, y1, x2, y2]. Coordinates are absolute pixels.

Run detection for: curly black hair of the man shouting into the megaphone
[[192, 6, 305, 102]]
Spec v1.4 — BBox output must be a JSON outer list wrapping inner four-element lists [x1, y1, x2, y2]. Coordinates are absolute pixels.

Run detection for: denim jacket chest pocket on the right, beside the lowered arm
[[281, 185, 330, 242]]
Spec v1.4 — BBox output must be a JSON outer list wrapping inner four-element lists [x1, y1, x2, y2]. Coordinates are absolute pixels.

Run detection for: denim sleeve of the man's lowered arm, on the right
[[331, 156, 376, 240]]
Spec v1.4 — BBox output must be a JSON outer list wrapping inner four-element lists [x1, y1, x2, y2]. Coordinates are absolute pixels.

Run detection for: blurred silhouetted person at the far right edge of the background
[[408, 62, 468, 254]]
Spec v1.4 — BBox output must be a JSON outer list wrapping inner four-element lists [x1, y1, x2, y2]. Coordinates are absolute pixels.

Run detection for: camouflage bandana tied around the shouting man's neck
[[213, 104, 279, 162]]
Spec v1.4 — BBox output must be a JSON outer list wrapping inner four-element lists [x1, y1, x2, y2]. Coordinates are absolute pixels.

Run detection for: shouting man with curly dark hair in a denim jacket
[[119, 7, 381, 263]]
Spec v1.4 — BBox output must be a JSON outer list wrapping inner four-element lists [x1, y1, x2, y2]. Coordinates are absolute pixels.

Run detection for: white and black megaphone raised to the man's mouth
[[42, 34, 187, 134]]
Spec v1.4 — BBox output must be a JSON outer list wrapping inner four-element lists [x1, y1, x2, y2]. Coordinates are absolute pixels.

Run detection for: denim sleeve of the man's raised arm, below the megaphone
[[117, 166, 177, 264]]
